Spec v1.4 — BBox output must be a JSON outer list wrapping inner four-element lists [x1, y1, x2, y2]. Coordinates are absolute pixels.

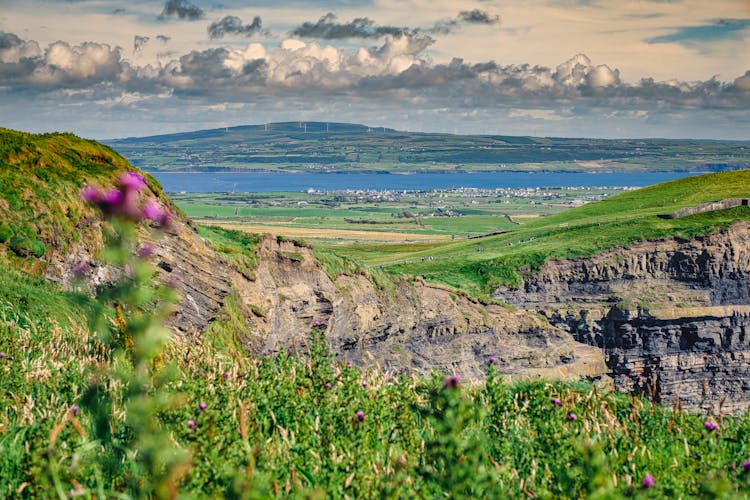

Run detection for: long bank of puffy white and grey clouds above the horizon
[[0, 33, 750, 128]]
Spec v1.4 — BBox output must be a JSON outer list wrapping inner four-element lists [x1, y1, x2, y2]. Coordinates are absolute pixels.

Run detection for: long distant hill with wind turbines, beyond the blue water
[[107, 122, 750, 172]]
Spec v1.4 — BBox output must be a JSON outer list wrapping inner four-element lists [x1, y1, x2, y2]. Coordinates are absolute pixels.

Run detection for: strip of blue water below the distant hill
[[152, 172, 695, 193]]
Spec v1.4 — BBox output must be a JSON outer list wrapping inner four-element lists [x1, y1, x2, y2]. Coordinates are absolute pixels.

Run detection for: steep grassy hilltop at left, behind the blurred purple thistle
[[0, 128, 176, 271]]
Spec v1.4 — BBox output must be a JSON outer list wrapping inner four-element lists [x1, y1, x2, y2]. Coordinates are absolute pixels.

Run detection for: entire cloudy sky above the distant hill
[[0, 0, 750, 140]]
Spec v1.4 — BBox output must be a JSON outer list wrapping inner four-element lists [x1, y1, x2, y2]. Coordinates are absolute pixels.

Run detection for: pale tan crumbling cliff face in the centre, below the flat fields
[[235, 238, 606, 380]]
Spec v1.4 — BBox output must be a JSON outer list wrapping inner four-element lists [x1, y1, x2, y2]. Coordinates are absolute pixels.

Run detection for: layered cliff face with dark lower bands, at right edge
[[494, 222, 750, 411]]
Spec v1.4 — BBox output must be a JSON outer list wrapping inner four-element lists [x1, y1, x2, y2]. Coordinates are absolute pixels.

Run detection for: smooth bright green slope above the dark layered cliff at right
[[334, 170, 750, 296]]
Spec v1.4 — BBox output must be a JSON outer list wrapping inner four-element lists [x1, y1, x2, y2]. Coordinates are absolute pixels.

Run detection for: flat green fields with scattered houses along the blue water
[[173, 188, 622, 243]]
